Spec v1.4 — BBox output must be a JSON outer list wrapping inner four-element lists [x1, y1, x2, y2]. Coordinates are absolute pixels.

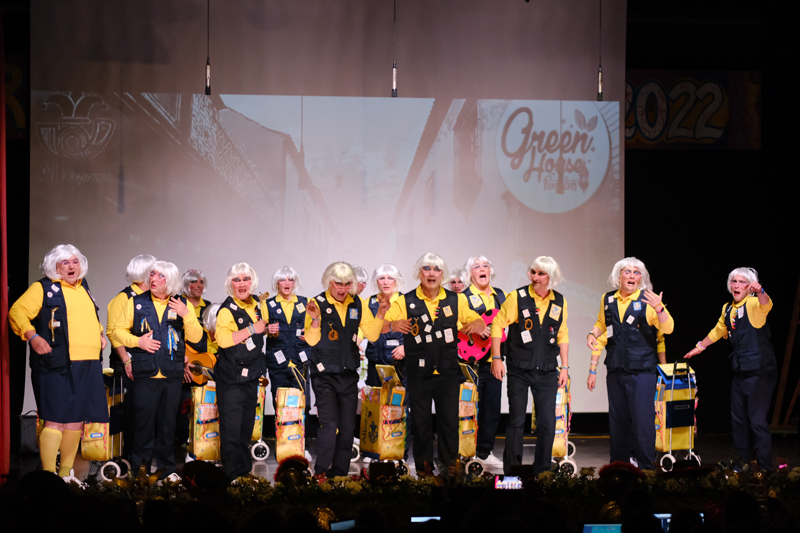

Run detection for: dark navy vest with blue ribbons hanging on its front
[[128, 291, 186, 379]]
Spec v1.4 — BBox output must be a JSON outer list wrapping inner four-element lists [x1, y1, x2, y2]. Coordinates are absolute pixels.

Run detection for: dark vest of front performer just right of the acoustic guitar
[[214, 295, 266, 384]]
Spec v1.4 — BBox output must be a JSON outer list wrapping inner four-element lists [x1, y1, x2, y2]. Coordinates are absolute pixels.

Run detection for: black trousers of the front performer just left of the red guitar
[[408, 374, 461, 472]]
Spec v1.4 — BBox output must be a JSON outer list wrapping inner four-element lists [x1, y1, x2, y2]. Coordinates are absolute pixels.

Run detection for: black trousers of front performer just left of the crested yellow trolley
[[311, 370, 358, 477]]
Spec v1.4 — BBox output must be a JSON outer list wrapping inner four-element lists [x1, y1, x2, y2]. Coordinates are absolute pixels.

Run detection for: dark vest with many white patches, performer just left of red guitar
[[403, 289, 461, 376]]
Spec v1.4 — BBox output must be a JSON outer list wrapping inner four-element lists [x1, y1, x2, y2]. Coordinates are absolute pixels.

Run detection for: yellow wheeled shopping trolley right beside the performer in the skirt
[[81, 368, 131, 481]]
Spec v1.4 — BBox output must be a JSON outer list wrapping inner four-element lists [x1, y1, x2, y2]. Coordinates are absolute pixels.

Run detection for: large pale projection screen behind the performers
[[26, 0, 625, 412]]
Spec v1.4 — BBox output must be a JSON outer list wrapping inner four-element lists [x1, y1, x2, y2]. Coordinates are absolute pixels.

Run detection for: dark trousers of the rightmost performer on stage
[[731, 370, 778, 470]]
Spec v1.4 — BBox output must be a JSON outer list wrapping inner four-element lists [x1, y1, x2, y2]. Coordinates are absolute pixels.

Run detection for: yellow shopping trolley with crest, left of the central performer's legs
[[359, 365, 409, 475]]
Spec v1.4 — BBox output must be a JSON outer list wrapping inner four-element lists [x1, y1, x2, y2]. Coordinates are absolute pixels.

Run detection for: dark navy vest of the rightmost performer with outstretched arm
[[725, 303, 777, 375]]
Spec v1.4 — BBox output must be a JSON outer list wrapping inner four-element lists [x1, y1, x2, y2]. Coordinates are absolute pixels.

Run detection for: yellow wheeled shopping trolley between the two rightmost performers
[[655, 361, 700, 471]]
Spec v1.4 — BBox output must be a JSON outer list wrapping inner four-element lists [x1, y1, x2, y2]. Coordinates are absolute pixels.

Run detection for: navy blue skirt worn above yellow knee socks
[[31, 361, 108, 424]]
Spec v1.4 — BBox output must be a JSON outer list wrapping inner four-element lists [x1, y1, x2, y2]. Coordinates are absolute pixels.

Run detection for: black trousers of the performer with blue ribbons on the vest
[[131, 377, 183, 478]]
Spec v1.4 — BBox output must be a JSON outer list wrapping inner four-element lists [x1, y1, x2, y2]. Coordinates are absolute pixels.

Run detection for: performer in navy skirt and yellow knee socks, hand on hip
[[8, 244, 108, 477]]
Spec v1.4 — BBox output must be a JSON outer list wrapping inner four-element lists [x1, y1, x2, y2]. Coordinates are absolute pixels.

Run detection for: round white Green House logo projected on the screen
[[496, 100, 619, 213]]
